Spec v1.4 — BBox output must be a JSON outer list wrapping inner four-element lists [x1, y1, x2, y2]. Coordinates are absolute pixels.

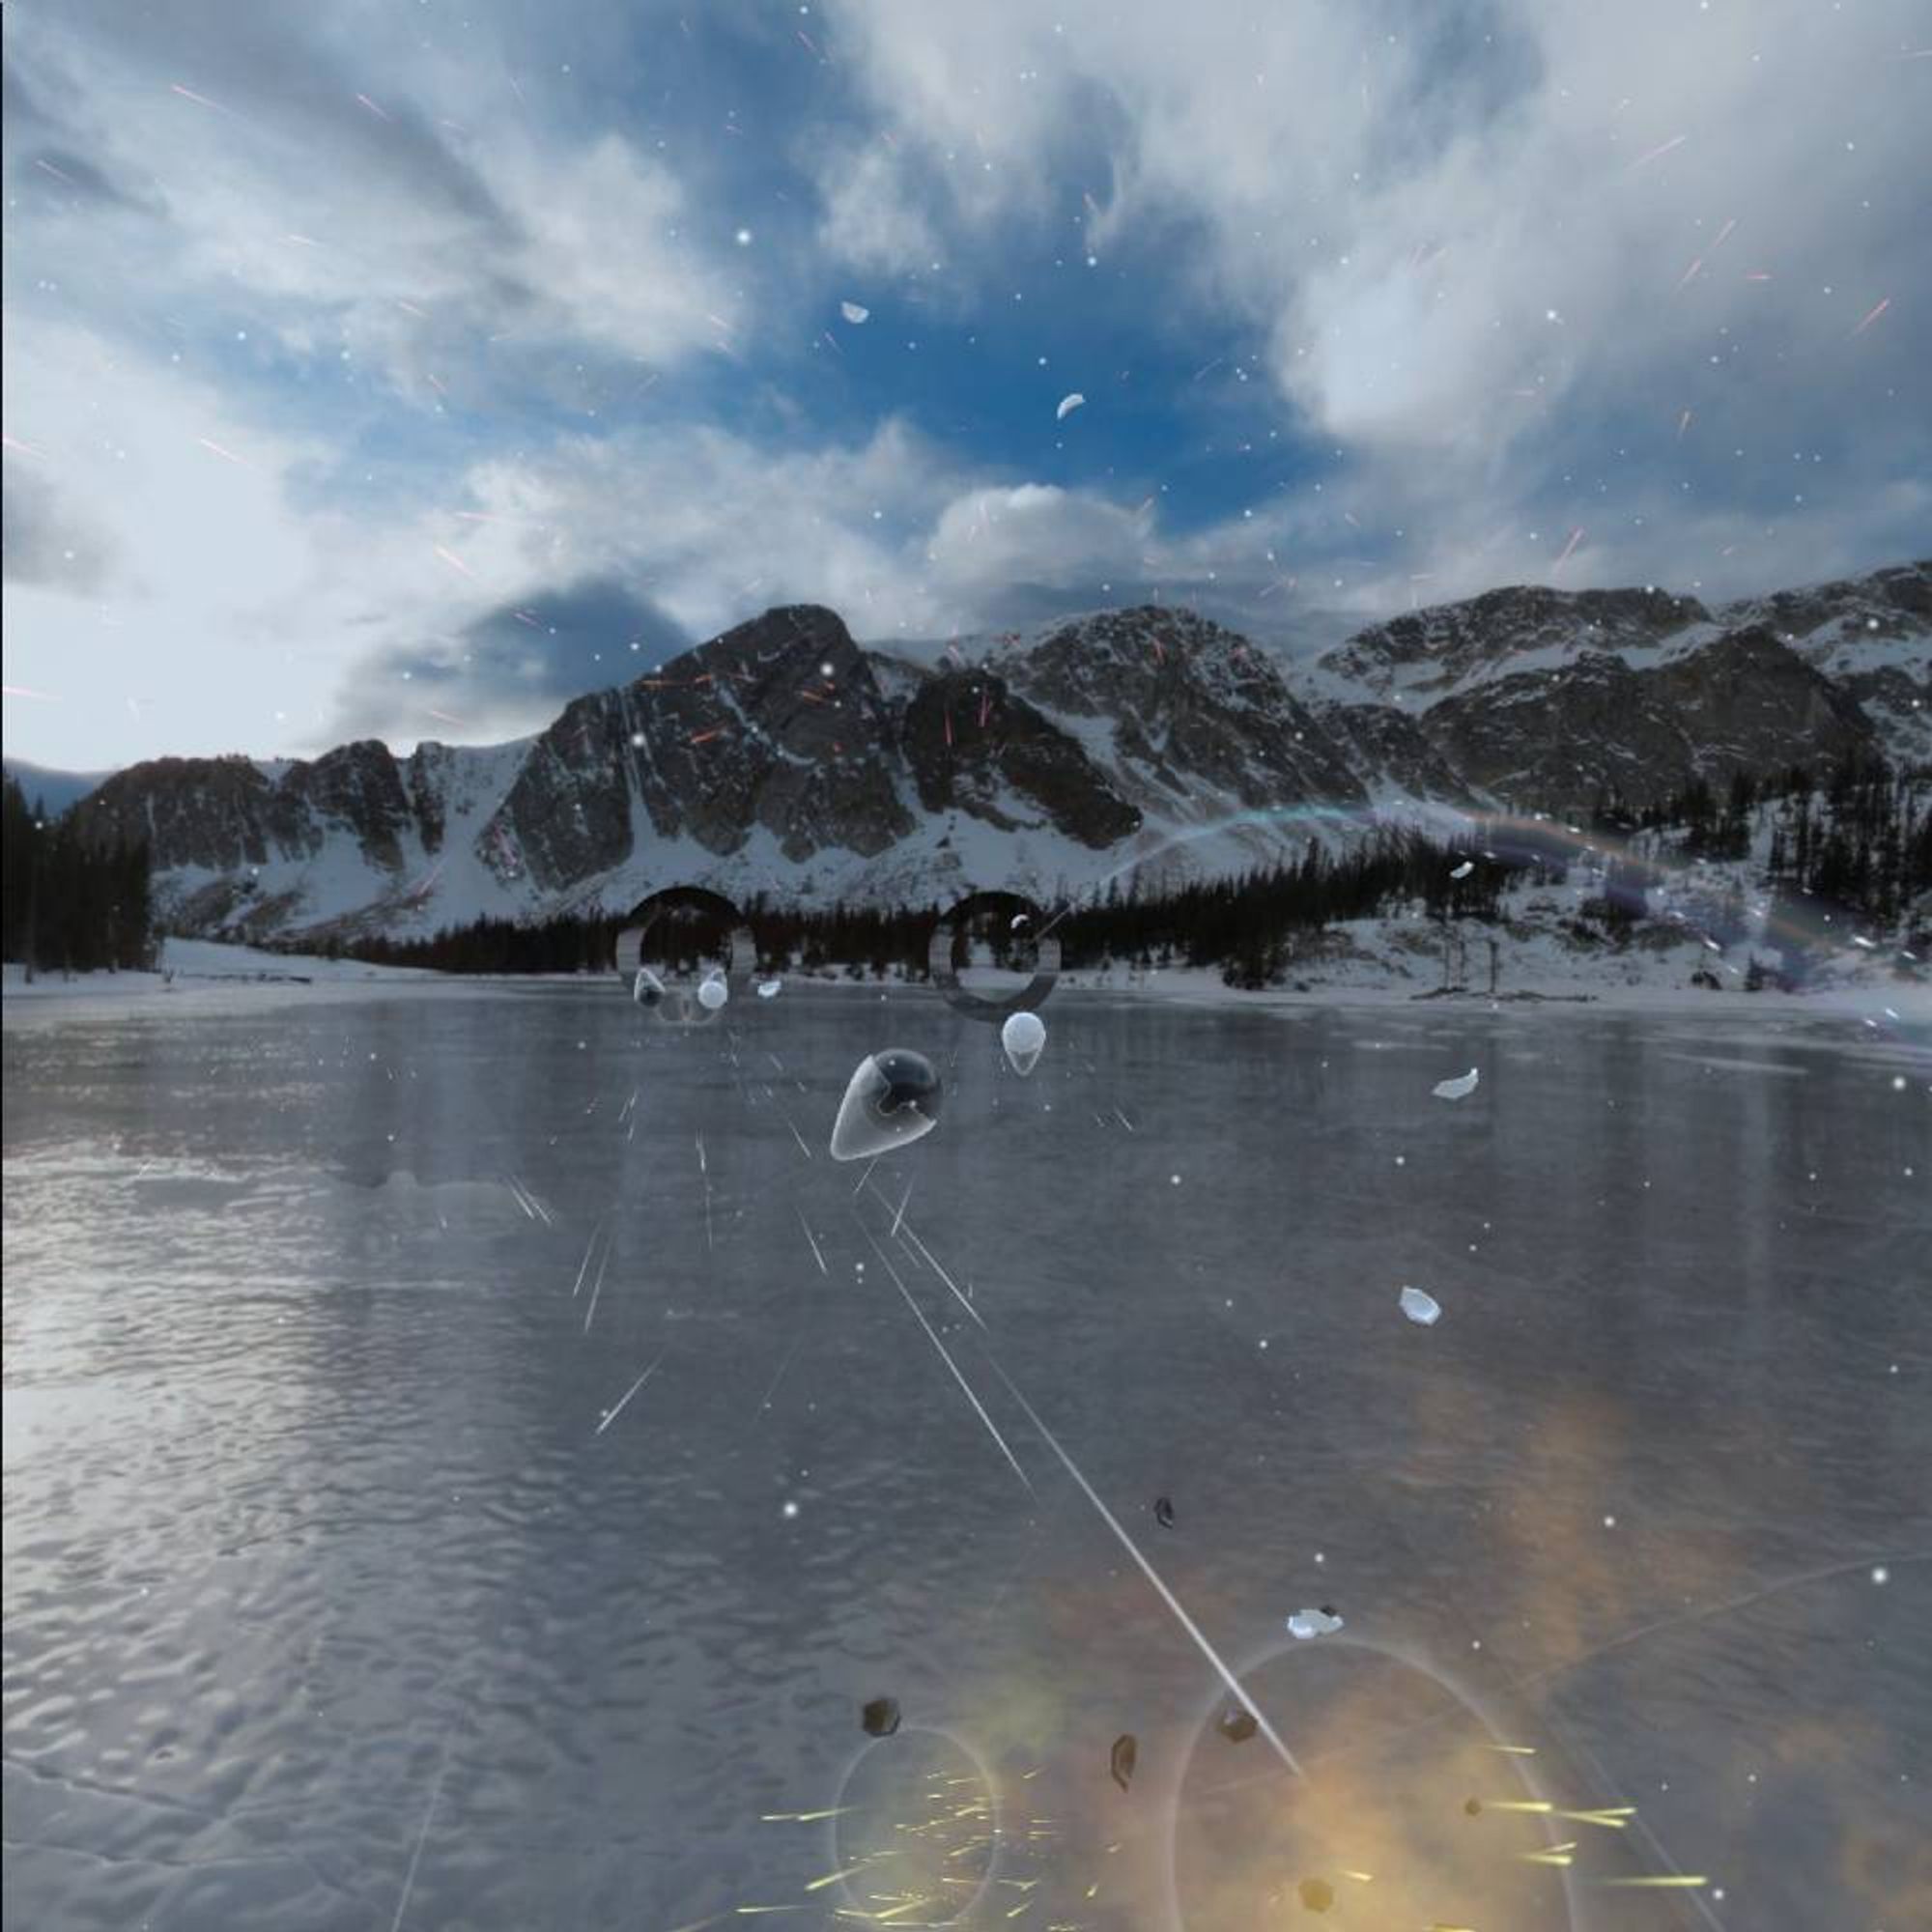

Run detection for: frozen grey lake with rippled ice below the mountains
[[4, 985, 1932, 1932]]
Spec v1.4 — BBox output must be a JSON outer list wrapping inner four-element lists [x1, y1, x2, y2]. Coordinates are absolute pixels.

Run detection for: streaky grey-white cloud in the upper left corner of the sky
[[8, 0, 742, 402]]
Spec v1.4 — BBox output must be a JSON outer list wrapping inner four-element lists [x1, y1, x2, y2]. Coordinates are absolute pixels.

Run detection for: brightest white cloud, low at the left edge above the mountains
[[6, 317, 498, 767]]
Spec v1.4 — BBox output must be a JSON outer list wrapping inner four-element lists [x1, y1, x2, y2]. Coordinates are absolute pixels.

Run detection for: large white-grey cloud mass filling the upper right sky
[[827, 0, 1932, 568]]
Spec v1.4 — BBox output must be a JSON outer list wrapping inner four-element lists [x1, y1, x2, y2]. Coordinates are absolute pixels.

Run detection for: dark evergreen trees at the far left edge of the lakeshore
[[0, 779, 155, 972]]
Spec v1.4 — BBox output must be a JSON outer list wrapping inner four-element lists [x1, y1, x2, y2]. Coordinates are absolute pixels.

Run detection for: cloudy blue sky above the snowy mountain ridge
[[0, 0, 1932, 769]]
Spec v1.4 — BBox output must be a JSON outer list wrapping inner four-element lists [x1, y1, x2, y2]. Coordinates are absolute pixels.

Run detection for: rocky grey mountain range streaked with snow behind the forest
[[64, 562, 1932, 939]]
